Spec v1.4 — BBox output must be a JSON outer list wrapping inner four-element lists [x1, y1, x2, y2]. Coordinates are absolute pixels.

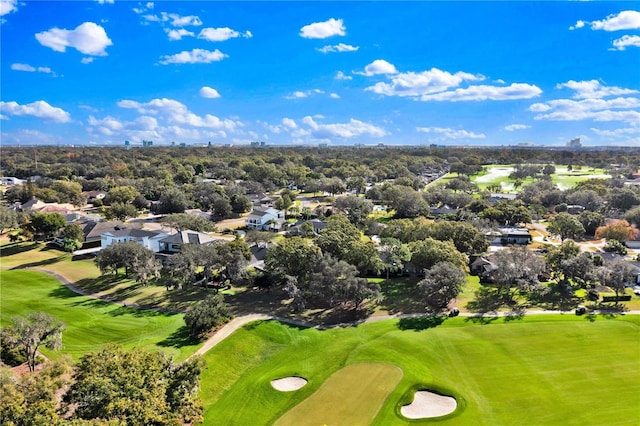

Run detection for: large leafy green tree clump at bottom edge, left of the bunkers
[[64, 344, 204, 426]]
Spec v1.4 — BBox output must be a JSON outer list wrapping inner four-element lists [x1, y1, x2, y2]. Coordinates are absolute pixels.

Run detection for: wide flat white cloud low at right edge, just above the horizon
[[529, 98, 640, 123]]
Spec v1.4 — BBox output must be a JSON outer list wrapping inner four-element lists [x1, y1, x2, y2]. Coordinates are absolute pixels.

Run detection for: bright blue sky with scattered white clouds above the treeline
[[0, 0, 640, 147]]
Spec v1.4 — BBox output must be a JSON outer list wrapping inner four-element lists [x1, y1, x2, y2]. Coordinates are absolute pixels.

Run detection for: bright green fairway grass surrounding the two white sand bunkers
[[200, 314, 640, 426]]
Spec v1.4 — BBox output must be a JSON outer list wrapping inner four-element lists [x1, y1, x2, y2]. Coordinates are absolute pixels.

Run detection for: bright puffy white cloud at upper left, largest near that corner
[[36, 22, 113, 56]]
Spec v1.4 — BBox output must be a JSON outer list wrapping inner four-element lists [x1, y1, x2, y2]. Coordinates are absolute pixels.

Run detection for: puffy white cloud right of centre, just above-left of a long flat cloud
[[365, 68, 484, 100]]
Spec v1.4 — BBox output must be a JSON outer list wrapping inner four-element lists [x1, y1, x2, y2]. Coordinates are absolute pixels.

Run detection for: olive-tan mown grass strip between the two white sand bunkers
[[275, 363, 402, 426]]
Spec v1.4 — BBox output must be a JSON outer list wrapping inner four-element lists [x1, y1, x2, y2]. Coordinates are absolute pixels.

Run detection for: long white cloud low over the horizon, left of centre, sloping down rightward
[[118, 98, 242, 130]]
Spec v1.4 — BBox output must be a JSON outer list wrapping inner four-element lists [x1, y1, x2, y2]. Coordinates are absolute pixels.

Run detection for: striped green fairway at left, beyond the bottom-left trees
[[0, 270, 198, 359]]
